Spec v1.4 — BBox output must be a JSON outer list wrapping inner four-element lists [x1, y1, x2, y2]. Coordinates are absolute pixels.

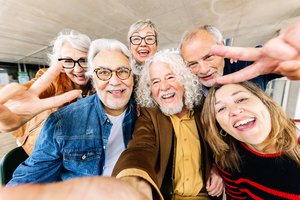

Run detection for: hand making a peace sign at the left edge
[[0, 66, 80, 132]]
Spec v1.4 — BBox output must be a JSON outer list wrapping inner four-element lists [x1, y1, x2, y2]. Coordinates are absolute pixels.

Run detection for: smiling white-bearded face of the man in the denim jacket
[[93, 51, 133, 116]]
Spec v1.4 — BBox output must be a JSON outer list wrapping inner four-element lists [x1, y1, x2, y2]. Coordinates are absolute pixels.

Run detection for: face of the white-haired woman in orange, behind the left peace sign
[[60, 42, 88, 88]]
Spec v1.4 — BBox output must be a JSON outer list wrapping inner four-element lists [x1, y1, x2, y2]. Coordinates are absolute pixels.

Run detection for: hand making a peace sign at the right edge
[[211, 23, 300, 84]]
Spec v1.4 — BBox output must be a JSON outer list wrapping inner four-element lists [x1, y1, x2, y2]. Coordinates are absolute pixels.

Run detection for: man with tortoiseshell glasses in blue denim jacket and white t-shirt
[[8, 39, 136, 185]]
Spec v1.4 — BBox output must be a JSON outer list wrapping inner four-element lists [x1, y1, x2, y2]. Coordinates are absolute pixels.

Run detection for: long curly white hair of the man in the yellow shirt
[[135, 51, 202, 109]]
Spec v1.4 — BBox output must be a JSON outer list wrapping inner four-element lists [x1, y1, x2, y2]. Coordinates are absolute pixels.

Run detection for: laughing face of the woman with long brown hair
[[215, 84, 271, 149]]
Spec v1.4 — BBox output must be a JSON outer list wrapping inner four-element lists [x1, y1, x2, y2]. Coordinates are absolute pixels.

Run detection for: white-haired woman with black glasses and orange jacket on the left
[[11, 30, 94, 155]]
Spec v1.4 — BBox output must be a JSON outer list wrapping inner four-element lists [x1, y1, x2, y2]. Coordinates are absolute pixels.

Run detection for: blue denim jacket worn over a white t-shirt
[[8, 94, 136, 185]]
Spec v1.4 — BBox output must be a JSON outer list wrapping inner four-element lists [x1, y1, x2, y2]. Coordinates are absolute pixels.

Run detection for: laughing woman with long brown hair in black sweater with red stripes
[[201, 82, 300, 199]]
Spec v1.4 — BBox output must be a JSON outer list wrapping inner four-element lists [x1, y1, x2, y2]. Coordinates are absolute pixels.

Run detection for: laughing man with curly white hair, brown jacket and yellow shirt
[[113, 52, 223, 199]]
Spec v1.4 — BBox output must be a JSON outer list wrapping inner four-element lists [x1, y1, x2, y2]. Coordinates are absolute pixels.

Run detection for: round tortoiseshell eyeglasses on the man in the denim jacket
[[94, 67, 131, 81]]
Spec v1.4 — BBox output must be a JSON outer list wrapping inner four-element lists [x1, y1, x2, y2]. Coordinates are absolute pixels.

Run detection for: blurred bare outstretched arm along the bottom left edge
[[0, 177, 147, 200]]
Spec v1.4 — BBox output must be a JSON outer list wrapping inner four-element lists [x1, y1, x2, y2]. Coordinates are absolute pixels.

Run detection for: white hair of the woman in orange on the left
[[48, 29, 91, 66]]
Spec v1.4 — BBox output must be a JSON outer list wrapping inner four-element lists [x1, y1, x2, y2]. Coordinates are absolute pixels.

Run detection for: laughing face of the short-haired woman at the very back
[[130, 27, 157, 64]]
